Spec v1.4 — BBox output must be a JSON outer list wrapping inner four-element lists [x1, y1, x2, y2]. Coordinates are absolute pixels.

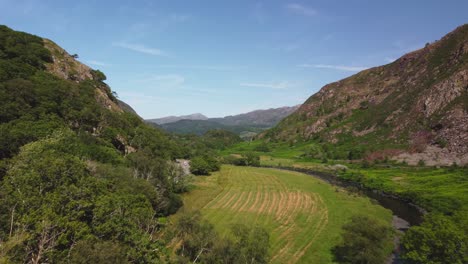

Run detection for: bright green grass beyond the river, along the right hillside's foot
[[223, 141, 468, 214]]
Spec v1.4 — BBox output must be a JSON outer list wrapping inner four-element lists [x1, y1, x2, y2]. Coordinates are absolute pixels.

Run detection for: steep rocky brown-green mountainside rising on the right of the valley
[[259, 25, 468, 164]]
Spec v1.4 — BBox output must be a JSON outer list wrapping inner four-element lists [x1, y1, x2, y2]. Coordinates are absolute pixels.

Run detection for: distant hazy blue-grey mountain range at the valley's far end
[[146, 105, 299, 138]]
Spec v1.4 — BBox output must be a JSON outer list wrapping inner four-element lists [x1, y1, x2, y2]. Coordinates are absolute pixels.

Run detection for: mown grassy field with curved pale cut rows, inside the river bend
[[175, 166, 391, 263]]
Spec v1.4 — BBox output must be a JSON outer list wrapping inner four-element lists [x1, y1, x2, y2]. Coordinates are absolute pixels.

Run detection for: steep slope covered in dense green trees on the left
[[0, 26, 187, 263]]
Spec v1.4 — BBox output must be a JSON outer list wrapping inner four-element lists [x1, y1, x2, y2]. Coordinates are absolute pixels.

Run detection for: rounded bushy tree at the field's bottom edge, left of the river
[[333, 216, 394, 264]]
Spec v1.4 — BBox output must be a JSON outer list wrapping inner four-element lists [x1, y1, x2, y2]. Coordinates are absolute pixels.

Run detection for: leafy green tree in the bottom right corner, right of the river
[[402, 212, 468, 264]]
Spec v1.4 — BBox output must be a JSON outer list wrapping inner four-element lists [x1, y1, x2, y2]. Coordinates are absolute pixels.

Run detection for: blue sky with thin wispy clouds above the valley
[[0, 0, 468, 118]]
